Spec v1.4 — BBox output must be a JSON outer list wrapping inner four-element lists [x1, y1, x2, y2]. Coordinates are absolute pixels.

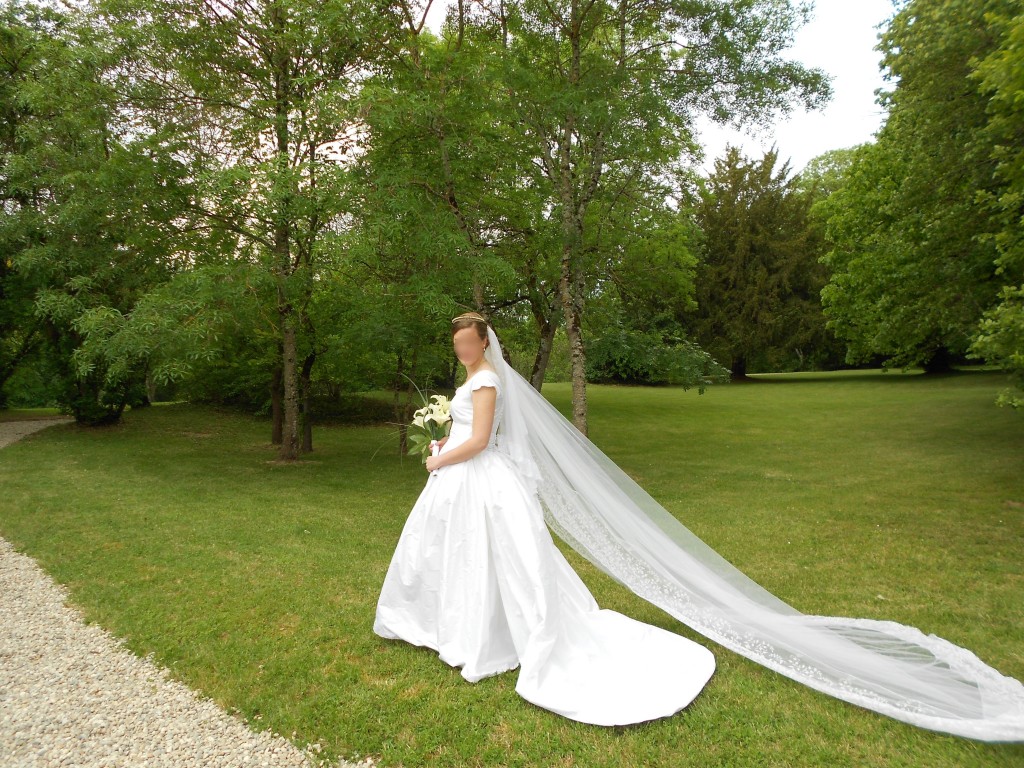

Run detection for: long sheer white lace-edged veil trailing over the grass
[[485, 326, 1024, 741]]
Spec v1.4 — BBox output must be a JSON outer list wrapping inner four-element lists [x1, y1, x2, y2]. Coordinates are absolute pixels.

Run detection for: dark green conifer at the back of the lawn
[[693, 147, 830, 379]]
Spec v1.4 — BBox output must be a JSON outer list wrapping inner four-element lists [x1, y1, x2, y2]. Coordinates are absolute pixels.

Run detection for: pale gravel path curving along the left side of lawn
[[0, 421, 374, 768]]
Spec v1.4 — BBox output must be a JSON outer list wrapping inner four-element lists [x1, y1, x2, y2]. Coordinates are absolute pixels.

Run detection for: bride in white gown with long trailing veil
[[374, 312, 1024, 741]]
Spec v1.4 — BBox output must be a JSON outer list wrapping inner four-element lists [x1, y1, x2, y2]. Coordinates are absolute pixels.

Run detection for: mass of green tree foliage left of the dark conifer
[[0, 0, 827, 428]]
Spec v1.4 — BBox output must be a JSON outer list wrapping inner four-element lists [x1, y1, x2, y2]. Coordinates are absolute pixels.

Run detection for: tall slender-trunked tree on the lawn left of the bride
[[90, 0, 395, 460]]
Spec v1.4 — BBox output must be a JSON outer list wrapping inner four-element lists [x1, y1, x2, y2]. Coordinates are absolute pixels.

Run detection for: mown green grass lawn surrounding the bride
[[0, 372, 1024, 768]]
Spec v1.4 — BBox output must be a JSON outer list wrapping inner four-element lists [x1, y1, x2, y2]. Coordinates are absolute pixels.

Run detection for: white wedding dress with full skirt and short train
[[374, 369, 715, 725]]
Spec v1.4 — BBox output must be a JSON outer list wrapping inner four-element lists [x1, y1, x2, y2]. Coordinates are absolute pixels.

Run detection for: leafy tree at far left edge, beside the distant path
[[0, 0, 180, 424]]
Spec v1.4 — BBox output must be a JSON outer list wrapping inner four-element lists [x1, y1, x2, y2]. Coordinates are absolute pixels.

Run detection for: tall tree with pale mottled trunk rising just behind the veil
[[487, 0, 827, 434]]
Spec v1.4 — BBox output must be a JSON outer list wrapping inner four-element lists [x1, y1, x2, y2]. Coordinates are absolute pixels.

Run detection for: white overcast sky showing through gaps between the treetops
[[427, 0, 893, 171]]
